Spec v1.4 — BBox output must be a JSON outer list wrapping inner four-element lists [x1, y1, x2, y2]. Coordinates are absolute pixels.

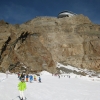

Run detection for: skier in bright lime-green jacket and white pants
[[18, 78, 26, 100]]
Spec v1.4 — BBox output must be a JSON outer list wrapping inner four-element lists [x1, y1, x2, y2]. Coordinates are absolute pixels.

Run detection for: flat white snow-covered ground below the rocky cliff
[[0, 72, 100, 100]]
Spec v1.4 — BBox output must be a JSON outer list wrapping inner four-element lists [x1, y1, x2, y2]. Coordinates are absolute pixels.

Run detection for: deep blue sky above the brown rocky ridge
[[0, 0, 100, 24]]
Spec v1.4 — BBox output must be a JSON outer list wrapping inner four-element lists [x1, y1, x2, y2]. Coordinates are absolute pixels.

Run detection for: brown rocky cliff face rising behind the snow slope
[[0, 15, 100, 73]]
